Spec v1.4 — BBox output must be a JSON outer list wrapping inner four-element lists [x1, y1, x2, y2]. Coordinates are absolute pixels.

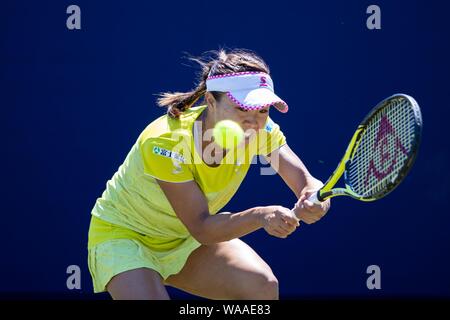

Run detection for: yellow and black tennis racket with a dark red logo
[[308, 94, 422, 204]]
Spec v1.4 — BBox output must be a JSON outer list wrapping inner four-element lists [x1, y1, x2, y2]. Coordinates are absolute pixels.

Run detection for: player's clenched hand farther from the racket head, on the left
[[260, 206, 299, 238]]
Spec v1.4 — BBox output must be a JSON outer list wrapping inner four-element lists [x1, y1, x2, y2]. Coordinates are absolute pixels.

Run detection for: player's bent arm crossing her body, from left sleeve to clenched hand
[[157, 180, 298, 244]]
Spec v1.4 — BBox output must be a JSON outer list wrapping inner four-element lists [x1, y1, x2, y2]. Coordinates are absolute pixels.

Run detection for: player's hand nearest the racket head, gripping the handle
[[292, 178, 331, 224]]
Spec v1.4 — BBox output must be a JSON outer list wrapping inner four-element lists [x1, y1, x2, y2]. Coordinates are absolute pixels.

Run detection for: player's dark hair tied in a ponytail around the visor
[[157, 49, 270, 118]]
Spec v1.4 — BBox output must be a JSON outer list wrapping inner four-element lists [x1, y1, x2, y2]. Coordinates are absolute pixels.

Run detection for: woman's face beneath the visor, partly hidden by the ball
[[208, 94, 270, 140]]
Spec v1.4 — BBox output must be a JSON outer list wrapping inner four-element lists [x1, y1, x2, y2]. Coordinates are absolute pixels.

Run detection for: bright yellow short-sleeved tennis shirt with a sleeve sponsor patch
[[90, 106, 286, 246]]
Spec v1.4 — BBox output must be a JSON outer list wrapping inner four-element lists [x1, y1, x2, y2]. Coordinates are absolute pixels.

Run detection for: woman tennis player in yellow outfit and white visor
[[88, 50, 330, 299]]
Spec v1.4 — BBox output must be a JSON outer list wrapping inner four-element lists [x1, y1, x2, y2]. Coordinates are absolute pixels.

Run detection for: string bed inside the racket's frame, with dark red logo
[[347, 98, 416, 197]]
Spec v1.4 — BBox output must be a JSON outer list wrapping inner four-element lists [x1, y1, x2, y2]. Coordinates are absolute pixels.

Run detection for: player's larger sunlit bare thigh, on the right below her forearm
[[165, 239, 278, 299]]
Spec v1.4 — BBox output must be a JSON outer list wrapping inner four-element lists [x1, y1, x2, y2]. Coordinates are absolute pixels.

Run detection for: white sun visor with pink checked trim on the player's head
[[206, 72, 288, 113]]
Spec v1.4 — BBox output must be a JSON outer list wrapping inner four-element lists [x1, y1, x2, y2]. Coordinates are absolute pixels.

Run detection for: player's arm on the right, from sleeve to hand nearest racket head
[[266, 144, 330, 224]]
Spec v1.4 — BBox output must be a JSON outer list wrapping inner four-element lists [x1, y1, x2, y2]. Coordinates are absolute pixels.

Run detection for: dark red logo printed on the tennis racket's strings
[[364, 115, 408, 186]]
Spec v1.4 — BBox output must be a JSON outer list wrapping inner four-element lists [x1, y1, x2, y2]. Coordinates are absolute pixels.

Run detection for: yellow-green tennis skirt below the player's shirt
[[88, 216, 200, 293]]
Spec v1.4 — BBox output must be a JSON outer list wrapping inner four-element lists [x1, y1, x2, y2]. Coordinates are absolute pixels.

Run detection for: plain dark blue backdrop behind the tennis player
[[0, 0, 450, 299]]
